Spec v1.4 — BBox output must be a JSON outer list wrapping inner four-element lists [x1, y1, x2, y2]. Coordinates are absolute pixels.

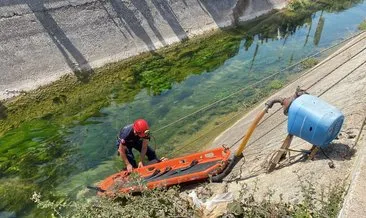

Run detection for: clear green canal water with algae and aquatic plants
[[0, 1, 366, 216]]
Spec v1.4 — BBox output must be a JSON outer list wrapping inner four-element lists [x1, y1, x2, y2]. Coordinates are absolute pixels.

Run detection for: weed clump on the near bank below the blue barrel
[[222, 177, 345, 217]]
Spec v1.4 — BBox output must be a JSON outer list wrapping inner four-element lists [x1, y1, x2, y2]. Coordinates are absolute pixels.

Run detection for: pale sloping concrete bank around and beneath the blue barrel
[[197, 32, 366, 217]]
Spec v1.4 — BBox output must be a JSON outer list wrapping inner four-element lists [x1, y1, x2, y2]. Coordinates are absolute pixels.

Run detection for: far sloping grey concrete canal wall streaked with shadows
[[0, 0, 287, 99]]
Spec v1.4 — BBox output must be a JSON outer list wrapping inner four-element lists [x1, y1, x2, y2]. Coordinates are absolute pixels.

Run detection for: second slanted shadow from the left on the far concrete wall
[[110, 0, 156, 51]]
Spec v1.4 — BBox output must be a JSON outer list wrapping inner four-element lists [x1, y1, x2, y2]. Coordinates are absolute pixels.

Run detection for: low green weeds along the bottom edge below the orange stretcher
[[32, 187, 199, 217]]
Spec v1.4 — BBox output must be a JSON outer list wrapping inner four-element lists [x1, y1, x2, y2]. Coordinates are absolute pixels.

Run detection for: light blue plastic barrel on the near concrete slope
[[287, 95, 344, 147]]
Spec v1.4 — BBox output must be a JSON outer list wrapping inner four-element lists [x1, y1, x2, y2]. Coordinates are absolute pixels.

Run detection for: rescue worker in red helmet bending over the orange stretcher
[[116, 119, 160, 172]]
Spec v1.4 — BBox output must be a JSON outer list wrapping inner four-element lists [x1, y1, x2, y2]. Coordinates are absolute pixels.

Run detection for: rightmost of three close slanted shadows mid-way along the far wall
[[152, 0, 187, 40]]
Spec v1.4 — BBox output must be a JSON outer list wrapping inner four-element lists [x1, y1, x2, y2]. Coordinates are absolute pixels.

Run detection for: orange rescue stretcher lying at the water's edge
[[96, 147, 230, 196]]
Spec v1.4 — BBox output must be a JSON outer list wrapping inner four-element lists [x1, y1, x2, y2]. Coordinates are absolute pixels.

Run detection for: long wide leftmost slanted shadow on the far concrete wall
[[25, 0, 93, 82]]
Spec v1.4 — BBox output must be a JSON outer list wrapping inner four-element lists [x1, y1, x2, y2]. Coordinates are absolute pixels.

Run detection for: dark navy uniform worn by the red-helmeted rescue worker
[[116, 124, 158, 168]]
